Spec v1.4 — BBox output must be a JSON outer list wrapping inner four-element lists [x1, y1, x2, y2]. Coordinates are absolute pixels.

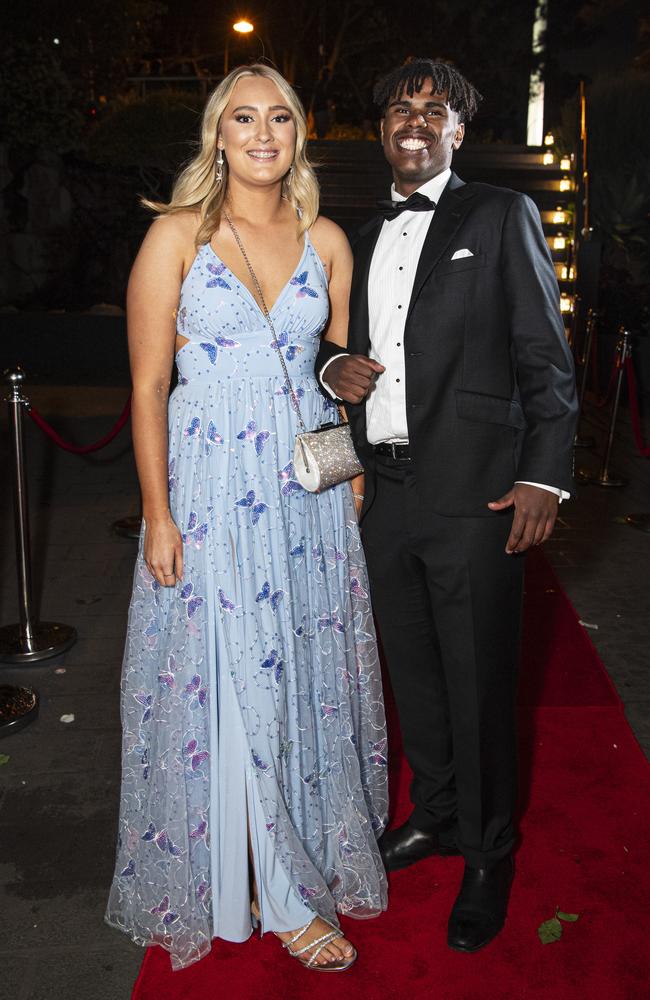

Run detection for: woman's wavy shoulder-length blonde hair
[[142, 63, 319, 246]]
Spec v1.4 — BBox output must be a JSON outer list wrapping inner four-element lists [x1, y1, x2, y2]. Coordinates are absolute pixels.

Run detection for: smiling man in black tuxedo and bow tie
[[316, 59, 576, 951]]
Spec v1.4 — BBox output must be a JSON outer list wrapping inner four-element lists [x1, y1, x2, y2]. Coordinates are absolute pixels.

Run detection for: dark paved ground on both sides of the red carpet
[[0, 387, 650, 1000]]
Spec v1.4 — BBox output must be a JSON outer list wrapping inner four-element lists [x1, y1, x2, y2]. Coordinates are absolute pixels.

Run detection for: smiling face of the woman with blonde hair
[[219, 76, 296, 187]]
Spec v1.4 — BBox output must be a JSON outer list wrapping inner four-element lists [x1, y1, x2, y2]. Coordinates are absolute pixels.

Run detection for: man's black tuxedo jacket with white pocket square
[[316, 173, 577, 517]]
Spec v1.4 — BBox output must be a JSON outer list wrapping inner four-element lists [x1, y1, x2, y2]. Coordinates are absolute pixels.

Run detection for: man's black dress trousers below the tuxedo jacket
[[361, 456, 524, 867]]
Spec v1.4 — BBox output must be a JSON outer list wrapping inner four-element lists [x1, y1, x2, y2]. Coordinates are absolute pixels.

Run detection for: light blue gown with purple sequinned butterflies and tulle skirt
[[106, 234, 387, 968]]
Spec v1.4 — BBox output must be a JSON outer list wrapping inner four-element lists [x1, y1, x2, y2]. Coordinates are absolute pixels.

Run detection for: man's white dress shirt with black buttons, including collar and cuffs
[[320, 169, 570, 501]]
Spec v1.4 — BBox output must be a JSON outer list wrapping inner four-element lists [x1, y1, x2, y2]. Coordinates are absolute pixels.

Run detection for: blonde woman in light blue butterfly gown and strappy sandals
[[107, 65, 387, 970]]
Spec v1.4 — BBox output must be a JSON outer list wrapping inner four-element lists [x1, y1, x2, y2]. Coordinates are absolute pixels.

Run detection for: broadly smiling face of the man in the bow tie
[[381, 80, 465, 196]]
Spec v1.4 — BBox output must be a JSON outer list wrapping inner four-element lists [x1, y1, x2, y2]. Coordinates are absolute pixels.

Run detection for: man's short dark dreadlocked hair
[[373, 58, 483, 122]]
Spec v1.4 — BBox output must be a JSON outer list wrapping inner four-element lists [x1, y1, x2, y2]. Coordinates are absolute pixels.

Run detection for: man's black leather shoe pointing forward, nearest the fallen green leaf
[[447, 855, 514, 951]]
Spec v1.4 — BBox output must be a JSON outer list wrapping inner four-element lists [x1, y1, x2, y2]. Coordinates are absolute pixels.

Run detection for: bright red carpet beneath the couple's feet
[[133, 553, 650, 1000]]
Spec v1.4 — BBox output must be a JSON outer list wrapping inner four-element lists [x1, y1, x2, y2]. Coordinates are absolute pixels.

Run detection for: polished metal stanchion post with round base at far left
[[0, 368, 77, 663]]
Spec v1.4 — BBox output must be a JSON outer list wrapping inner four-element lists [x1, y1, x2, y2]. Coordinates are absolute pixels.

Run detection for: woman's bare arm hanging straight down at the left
[[127, 216, 188, 587]]
